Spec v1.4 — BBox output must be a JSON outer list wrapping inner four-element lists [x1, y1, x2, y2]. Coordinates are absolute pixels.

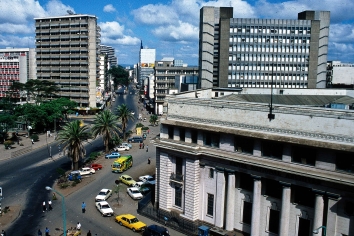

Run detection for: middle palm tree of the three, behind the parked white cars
[[91, 110, 122, 153]]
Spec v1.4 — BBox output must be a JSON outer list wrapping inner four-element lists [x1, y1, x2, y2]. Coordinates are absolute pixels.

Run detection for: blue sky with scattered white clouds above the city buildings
[[0, 0, 354, 66]]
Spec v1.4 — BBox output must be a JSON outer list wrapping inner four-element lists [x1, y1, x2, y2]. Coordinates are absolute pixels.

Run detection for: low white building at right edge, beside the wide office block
[[327, 61, 354, 88]]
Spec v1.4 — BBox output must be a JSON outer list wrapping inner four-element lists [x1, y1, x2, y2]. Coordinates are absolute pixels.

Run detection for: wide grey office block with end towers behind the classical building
[[199, 7, 330, 89]]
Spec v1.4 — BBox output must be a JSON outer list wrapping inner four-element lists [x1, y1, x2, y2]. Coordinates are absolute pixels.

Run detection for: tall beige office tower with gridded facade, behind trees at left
[[35, 14, 100, 108]]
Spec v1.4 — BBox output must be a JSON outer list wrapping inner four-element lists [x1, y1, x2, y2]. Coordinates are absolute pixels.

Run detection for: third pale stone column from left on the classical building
[[251, 176, 262, 236]]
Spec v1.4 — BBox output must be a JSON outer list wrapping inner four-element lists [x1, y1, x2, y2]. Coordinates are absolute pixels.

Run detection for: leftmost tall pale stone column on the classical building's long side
[[215, 167, 225, 228]]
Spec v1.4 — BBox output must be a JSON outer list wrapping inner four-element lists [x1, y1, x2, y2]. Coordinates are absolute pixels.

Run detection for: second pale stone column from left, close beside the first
[[225, 170, 236, 231]]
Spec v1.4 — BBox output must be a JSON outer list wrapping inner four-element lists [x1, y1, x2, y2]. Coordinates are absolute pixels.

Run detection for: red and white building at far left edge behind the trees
[[0, 48, 36, 98]]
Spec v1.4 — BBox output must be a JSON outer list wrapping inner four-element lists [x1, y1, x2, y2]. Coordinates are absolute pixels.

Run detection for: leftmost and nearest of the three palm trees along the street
[[58, 120, 90, 170]]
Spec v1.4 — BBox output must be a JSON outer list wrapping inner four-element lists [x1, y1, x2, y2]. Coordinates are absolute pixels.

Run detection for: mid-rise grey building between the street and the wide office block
[[154, 58, 199, 114]]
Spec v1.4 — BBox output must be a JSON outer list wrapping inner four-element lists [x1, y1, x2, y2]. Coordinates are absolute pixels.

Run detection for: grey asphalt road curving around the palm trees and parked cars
[[0, 85, 183, 236]]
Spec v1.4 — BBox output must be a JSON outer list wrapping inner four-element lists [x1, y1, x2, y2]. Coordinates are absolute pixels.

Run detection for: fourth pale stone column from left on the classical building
[[279, 182, 291, 236]]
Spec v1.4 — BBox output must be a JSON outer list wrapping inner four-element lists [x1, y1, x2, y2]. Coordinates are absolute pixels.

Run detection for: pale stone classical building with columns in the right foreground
[[155, 89, 354, 236]]
